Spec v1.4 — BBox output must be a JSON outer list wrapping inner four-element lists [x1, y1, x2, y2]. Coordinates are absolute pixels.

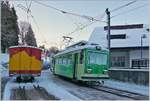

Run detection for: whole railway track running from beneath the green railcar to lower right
[[53, 75, 149, 100]]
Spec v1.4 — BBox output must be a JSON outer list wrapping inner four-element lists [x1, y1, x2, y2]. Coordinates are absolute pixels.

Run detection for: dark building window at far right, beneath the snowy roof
[[132, 59, 149, 67]]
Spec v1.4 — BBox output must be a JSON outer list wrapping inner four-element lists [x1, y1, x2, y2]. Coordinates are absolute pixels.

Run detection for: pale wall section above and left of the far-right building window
[[129, 50, 149, 67]]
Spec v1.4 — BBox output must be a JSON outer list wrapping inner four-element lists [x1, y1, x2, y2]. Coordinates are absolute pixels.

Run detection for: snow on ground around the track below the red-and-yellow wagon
[[3, 70, 80, 100]]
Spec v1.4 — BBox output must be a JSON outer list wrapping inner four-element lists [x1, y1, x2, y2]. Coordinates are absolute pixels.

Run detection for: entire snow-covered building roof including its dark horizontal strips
[[88, 24, 149, 48]]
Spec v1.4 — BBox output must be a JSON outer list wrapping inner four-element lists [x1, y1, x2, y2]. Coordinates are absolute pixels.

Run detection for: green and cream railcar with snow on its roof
[[53, 46, 109, 81]]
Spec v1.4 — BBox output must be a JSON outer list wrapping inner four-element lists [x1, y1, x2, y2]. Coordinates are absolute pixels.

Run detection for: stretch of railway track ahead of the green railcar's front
[[88, 85, 149, 100]]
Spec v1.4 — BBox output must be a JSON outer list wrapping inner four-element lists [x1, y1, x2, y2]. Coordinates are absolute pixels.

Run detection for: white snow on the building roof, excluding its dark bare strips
[[88, 23, 149, 48]]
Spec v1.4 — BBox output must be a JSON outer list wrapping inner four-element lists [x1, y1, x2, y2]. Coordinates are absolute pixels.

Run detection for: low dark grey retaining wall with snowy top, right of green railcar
[[108, 69, 149, 86]]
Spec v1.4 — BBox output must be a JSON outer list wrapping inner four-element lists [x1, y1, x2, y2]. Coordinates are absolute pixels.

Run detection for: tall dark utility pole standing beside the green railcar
[[105, 8, 111, 68]]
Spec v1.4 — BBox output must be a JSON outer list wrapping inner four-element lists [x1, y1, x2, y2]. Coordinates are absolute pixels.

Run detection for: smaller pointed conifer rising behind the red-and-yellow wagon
[[25, 25, 37, 47]]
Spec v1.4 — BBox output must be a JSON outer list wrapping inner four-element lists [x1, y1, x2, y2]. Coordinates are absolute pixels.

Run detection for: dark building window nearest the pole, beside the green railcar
[[111, 56, 125, 67]]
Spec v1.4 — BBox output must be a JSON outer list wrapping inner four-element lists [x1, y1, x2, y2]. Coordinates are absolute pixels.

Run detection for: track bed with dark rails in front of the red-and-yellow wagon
[[13, 83, 58, 100]]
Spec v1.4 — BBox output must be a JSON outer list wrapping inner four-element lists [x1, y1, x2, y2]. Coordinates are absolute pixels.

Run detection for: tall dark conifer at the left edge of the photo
[[1, 1, 19, 53]]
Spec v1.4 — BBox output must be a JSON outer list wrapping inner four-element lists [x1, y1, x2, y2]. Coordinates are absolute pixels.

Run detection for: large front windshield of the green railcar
[[88, 52, 107, 65]]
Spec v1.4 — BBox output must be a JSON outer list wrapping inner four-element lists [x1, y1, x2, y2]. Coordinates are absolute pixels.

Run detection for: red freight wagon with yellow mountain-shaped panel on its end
[[9, 46, 42, 82]]
